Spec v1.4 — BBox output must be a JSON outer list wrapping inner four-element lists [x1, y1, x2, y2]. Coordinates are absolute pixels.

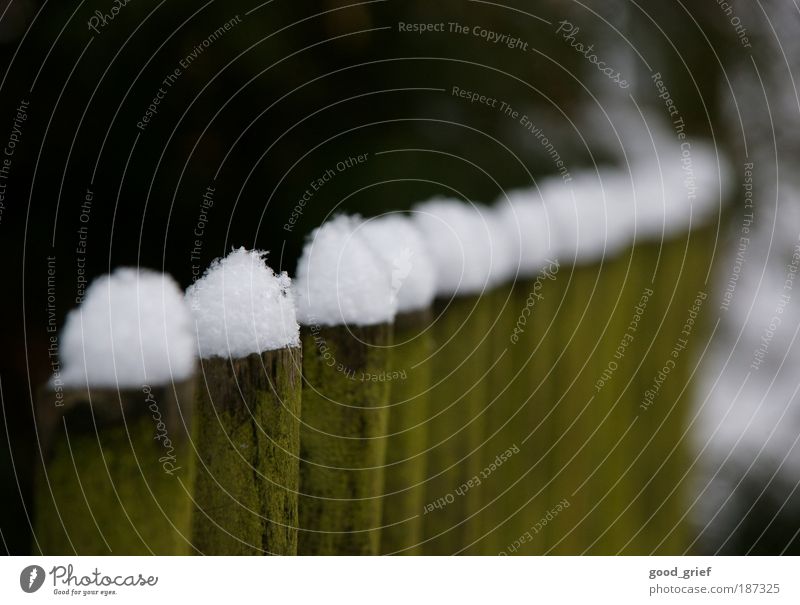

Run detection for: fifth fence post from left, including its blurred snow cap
[[414, 198, 504, 555]]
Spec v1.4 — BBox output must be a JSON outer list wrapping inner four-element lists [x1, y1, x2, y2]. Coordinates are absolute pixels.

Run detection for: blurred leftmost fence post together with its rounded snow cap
[[35, 269, 194, 555]]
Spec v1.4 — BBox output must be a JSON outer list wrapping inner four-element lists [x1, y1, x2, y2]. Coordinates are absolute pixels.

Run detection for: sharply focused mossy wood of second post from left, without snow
[[192, 347, 301, 555]]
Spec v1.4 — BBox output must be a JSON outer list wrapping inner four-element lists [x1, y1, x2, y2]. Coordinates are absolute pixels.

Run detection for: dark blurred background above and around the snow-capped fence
[[0, 0, 800, 554]]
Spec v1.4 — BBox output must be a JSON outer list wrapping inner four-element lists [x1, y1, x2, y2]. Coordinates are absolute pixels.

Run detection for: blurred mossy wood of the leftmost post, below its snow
[[35, 380, 194, 556]]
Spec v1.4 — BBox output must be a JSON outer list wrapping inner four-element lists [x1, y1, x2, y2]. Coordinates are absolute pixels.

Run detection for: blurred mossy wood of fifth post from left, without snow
[[423, 296, 493, 555]]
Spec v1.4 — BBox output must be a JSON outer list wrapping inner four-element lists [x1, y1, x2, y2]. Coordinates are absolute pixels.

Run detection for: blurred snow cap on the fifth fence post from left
[[412, 197, 492, 296]]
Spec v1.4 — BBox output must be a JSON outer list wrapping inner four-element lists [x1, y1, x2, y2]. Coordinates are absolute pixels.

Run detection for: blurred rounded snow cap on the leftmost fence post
[[58, 268, 195, 387]]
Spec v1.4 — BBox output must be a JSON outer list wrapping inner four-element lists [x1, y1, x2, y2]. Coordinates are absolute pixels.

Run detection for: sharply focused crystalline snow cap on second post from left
[[186, 248, 300, 358]]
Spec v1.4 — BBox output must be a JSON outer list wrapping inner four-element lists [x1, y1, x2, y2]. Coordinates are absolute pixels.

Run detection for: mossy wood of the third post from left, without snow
[[298, 324, 393, 555]]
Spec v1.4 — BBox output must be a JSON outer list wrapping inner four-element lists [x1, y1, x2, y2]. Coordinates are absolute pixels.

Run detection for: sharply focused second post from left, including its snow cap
[[186, 249, 302, 555]]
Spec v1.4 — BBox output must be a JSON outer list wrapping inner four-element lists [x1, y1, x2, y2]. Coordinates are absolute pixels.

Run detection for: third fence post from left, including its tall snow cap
[[295, 216, 396, 555]]
